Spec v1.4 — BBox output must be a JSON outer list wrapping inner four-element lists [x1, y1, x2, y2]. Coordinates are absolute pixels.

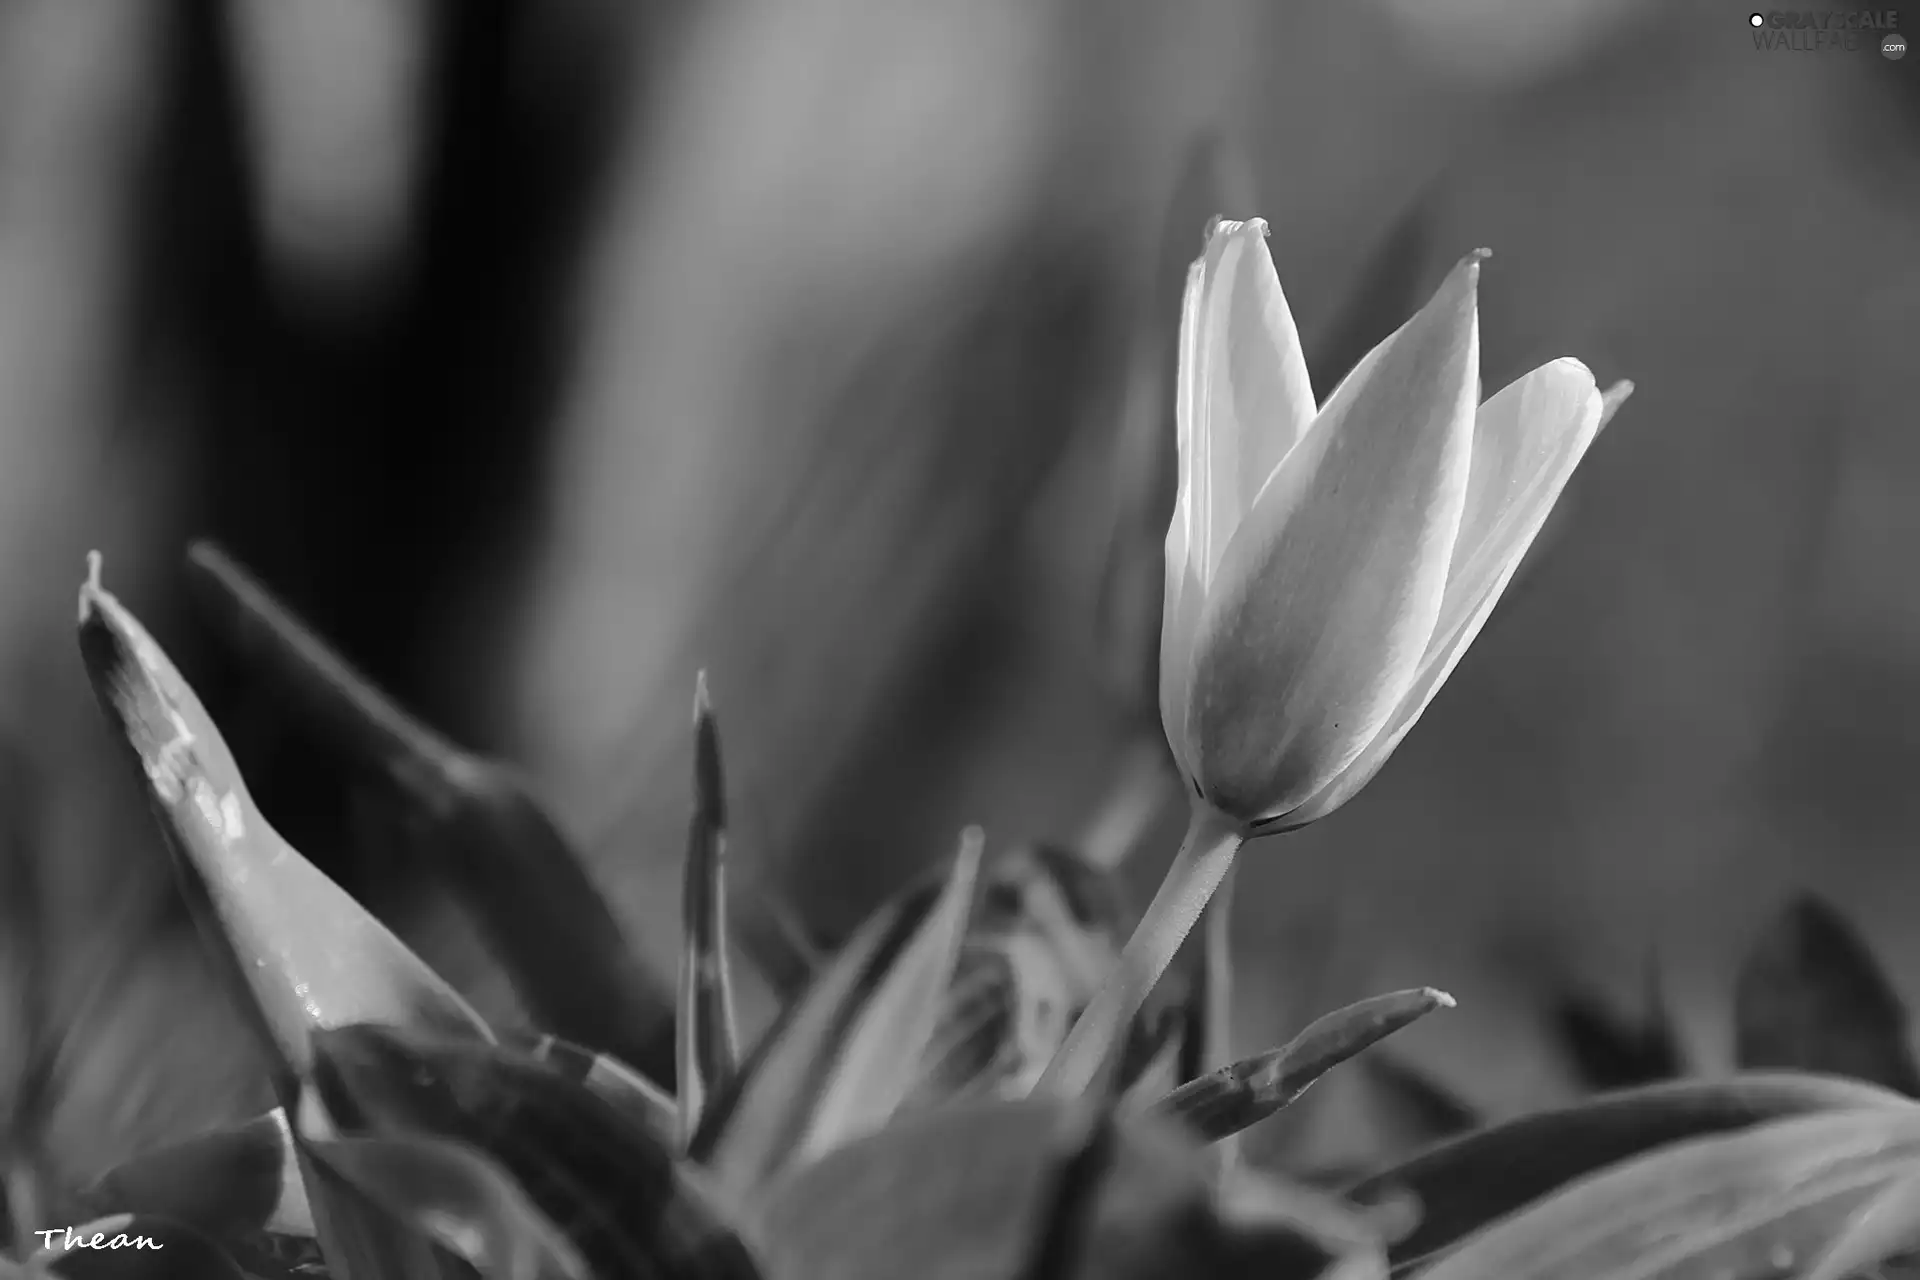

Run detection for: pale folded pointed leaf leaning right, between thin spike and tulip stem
[[689, 831, 981, 1196]]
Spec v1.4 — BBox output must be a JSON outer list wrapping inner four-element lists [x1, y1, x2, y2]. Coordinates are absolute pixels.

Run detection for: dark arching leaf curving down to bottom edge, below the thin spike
[[313, 1025, 758, 1280]]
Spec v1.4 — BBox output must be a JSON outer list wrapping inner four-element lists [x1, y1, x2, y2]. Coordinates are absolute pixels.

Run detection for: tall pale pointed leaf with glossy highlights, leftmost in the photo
[[79, 558, 490, 1103]]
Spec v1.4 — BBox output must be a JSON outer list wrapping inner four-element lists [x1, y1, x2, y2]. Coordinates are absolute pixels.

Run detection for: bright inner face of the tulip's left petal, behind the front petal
[[1175, 219, 1313, 583]]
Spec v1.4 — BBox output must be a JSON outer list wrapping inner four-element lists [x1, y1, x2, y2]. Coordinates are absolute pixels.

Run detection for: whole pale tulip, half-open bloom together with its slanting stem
[[1043, 219, 1632, 1092]]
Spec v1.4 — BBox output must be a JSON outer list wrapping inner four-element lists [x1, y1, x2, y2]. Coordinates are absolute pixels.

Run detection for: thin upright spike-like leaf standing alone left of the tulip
[[674, 672, 739, 1144]]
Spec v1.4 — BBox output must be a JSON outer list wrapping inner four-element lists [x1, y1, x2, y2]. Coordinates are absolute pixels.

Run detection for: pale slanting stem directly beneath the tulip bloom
[[1033, 806, 1244, 1098]]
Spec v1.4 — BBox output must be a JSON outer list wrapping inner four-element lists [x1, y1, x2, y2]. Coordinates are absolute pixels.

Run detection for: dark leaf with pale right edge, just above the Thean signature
[[83, 1109, 313, 1240]]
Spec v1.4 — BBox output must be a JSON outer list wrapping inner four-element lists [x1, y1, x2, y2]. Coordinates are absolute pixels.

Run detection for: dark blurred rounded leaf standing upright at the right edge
[[1734, 896, 1920, 1098]]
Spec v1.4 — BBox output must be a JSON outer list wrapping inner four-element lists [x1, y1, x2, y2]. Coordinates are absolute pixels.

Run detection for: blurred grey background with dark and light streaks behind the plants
[[0, 0, 1920, 1176]]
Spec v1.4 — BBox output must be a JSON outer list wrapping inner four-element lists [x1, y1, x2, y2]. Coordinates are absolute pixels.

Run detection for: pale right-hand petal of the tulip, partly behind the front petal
[[1273, 370, 1632, 831]]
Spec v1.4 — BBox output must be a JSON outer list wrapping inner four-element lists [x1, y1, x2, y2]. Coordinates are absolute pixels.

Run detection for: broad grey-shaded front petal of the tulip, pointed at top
[[1187, 253, 1482, 821]]
